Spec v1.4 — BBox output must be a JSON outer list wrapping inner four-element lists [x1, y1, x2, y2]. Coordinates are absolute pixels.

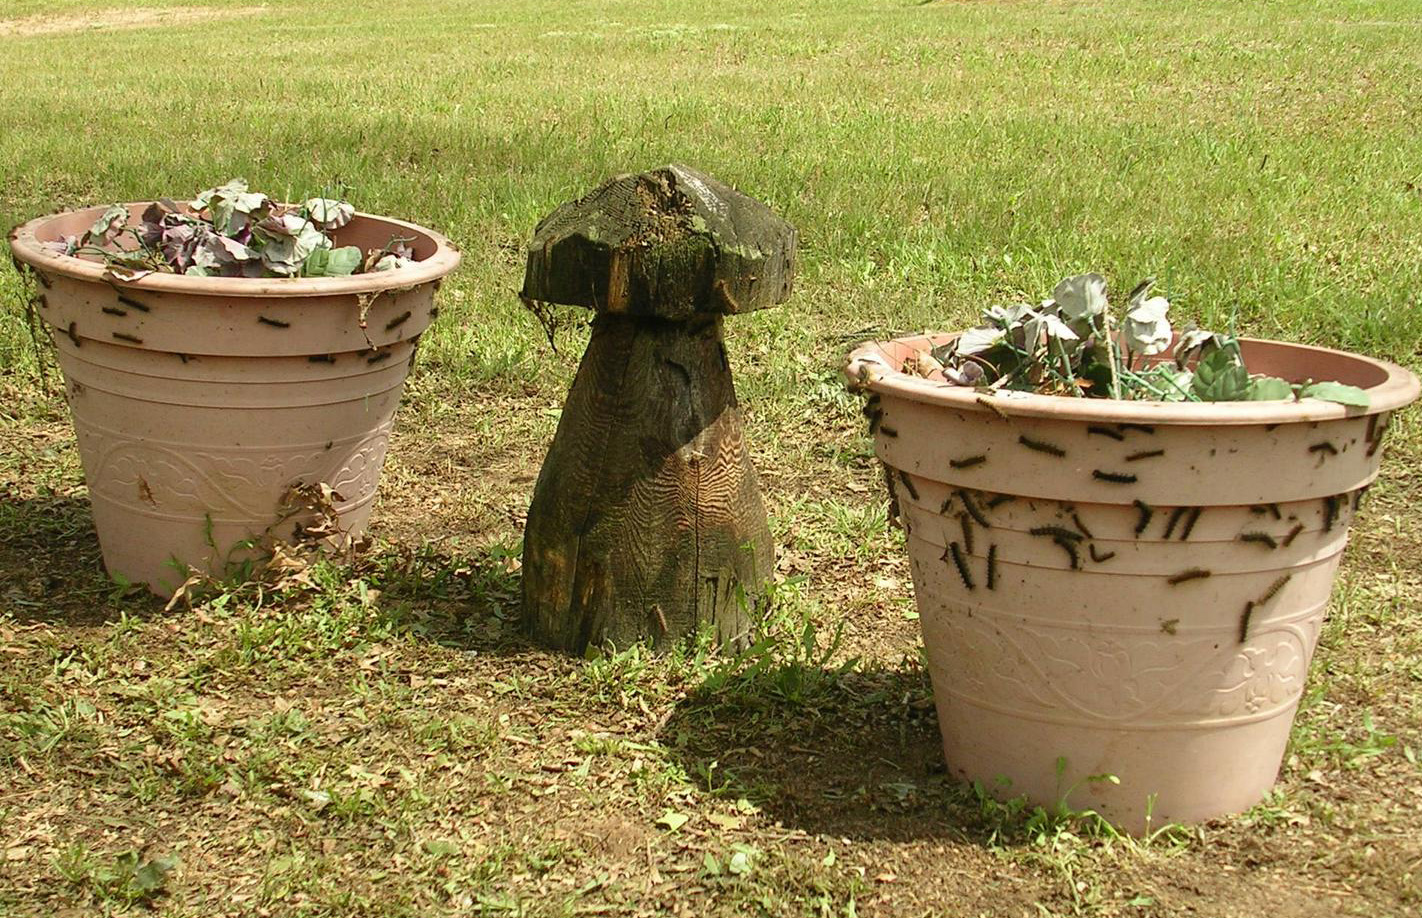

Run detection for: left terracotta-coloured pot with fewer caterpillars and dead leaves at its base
[[10, 203, 459, 594]]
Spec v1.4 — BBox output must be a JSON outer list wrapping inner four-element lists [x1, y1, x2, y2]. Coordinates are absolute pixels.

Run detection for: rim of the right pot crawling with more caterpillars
[[843, 333, 1422, 425]]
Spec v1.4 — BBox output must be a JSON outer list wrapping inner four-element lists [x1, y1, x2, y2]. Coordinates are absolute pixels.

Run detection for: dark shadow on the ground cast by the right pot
[[661, 665, 984, 841]]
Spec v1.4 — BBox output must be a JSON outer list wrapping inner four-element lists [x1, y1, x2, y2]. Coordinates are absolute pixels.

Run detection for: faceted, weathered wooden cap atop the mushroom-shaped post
[[523, 165, 795, 320]]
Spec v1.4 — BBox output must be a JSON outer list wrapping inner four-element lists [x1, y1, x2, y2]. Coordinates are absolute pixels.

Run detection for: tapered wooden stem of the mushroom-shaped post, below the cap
[[523, 315, 774, 652]]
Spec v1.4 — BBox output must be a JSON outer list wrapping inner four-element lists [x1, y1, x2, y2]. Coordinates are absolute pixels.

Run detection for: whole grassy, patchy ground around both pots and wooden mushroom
[[0, 0, 1422, 918]]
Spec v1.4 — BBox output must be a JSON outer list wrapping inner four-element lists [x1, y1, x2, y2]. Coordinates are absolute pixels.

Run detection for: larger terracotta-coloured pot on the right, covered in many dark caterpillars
[[846, 335, 1418, 831]]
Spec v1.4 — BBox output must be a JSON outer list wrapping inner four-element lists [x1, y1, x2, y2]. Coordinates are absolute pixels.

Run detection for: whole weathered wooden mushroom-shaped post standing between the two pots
[[523, 165, 795, 654]]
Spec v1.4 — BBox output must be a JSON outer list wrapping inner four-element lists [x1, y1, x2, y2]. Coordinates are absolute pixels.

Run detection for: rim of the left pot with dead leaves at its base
[[9, 200, 461, 297]]
